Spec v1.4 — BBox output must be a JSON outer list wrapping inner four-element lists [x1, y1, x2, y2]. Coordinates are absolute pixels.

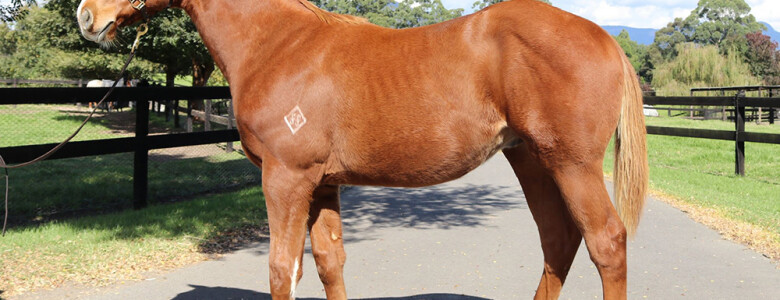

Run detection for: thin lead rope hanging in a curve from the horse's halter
[[0, 23, 149, 236]]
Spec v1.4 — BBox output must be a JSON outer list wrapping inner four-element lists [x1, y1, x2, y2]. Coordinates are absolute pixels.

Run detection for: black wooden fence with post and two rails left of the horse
[[0, 87, 239, 208]]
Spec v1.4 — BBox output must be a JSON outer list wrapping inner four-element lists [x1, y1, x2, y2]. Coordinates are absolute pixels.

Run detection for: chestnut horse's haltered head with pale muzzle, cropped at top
[[76, 0, 173, 45]]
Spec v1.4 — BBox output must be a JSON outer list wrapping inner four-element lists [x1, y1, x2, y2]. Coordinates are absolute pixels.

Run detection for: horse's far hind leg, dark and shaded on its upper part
[[504, 146, 582, 299]]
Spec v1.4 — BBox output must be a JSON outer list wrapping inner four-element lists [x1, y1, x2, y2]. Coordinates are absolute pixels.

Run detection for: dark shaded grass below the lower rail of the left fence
[[9, 152, 260, 223]]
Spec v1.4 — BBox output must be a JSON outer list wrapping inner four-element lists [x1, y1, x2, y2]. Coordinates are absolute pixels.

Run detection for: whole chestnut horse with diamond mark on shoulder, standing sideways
[[76, 0, 648, 299]]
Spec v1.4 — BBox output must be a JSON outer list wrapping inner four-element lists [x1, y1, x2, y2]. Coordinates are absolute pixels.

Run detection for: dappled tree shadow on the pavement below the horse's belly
[[341, 184, 527, 242]]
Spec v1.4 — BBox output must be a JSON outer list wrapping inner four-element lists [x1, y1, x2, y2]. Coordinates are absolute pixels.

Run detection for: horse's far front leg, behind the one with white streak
[[309, 185, 347, 299]]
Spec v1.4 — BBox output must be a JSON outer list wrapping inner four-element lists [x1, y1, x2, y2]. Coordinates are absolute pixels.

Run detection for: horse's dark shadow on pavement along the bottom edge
[[173, 285, 487, 300]]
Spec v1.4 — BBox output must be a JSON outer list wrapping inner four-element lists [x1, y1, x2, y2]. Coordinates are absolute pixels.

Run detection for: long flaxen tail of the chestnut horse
[[613, 52, 649, 237]]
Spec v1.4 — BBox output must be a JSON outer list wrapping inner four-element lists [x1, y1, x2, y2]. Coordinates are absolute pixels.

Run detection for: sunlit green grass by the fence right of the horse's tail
[[604, 118, 780, 241]]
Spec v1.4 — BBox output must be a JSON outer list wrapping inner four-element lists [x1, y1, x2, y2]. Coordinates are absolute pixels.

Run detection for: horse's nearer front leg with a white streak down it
[[263, 160, 314, 300]]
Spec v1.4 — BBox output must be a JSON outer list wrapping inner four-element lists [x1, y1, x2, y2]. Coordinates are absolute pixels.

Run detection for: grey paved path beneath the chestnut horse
[[18, 156, 780, 300]]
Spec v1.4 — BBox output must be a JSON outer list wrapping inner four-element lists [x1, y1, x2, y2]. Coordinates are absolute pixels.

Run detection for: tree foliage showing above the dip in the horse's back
[[312, 0, 463, 28]]
